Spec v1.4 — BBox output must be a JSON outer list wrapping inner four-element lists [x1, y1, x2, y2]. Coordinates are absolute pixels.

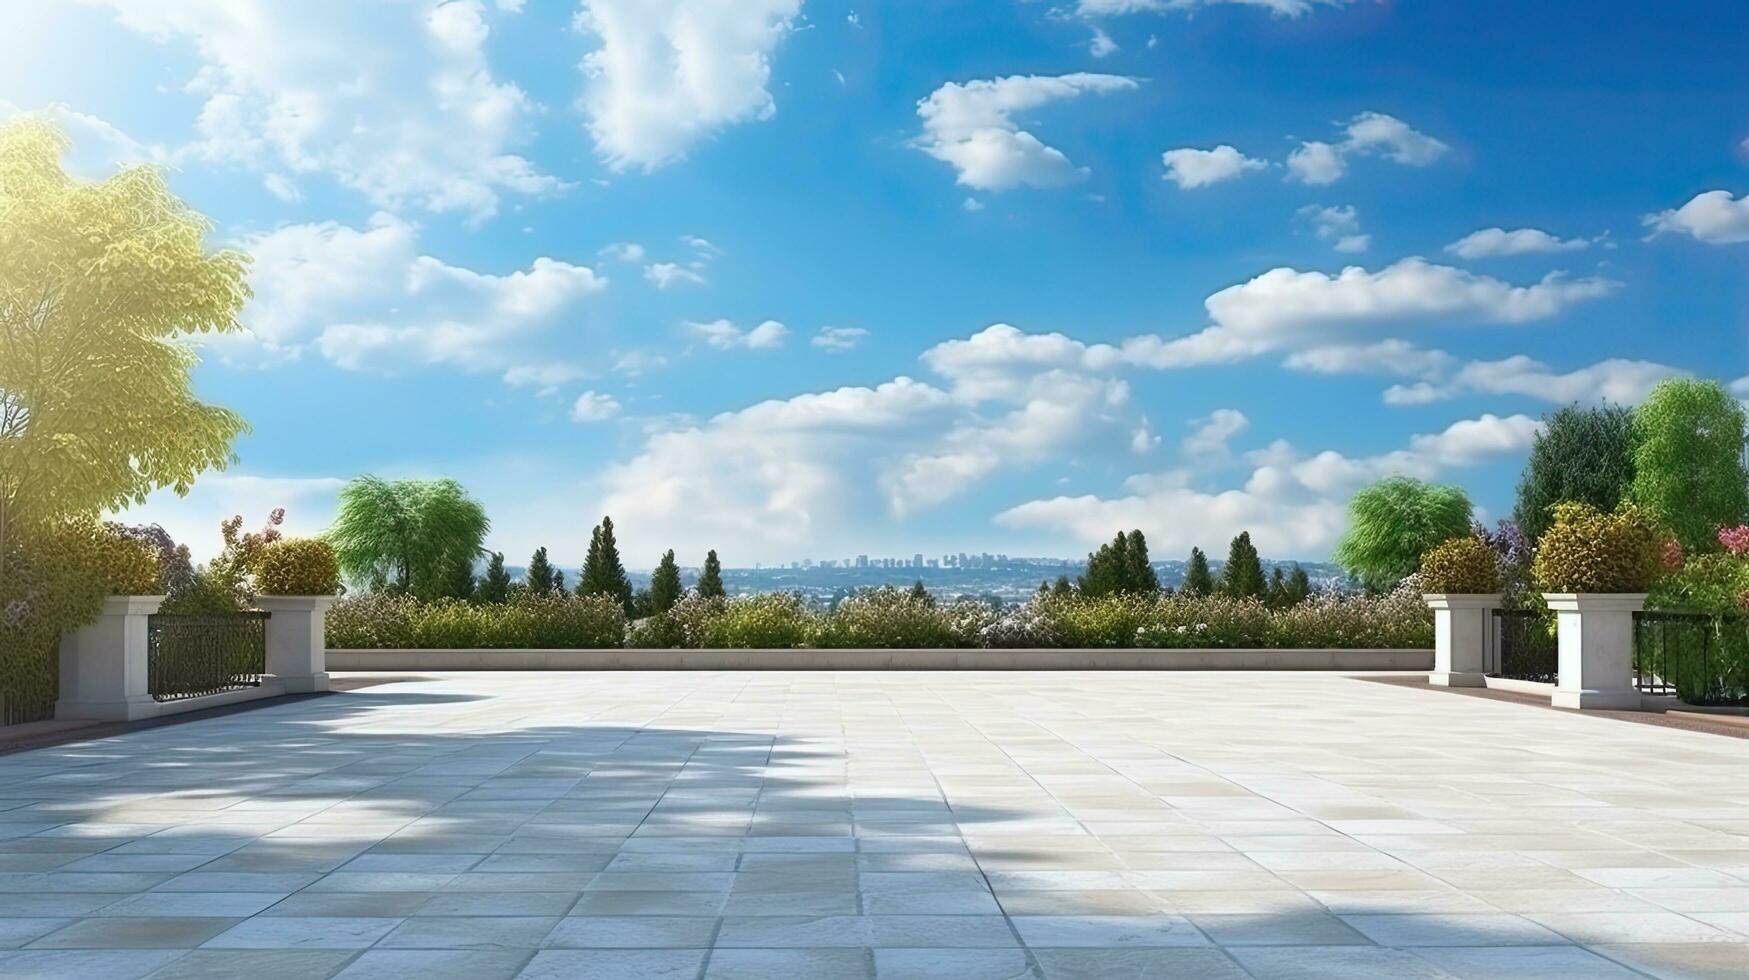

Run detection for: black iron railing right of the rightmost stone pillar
[[1634, 613, 1749, 705]]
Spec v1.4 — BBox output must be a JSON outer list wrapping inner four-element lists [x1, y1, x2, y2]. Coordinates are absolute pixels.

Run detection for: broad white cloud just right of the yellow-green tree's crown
[[236, 214, 607, 371]]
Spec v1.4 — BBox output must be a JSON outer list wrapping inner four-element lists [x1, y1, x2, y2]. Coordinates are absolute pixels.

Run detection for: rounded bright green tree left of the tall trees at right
[[1334, 476, 1471, 590]]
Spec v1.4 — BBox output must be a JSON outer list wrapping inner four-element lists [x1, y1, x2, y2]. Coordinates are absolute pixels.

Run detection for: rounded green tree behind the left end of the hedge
[[327, 476, 491, 599]]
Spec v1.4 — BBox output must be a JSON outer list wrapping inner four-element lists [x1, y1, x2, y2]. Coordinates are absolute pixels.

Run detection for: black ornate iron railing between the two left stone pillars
[[145, 613, 268, 702]]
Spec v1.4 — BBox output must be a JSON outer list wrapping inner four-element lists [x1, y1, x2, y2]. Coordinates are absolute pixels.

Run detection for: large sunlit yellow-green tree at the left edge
[[0, 117, 248, 644]]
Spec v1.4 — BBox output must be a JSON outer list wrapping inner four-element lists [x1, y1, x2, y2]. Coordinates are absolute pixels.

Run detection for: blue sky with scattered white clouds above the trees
[[0, 0, 1749, 567]]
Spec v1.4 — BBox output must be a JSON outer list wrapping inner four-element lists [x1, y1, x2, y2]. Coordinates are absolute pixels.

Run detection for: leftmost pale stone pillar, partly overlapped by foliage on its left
[[54, 595, 164, 721]]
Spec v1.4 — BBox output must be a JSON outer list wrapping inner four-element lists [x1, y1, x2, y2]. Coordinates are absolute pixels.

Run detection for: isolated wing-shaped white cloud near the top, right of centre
[[916, 72, 1137, 191]]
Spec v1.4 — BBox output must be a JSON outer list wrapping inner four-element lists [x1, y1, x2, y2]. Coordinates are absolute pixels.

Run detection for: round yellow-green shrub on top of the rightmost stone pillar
[[1530, 502, 1665, 593]]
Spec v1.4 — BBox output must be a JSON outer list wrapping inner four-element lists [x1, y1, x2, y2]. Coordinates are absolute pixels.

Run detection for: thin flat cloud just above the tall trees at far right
[[1385, 354, 1686, 404]]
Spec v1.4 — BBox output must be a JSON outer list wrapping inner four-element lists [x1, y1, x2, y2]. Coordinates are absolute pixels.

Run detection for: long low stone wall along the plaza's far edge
[[327, 649, 1432, 670]]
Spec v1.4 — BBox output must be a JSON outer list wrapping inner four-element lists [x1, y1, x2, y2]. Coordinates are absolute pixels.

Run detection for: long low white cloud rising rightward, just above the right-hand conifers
[[995, 415, 1539, 557]]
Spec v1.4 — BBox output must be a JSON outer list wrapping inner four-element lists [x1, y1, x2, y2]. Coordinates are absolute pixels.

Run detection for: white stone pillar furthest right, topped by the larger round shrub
[[1543, 592, 1646, 709]]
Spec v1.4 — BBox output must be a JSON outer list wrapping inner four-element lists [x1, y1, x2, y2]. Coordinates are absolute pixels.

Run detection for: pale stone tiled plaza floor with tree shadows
[[0, 672, 1749, 980]]
